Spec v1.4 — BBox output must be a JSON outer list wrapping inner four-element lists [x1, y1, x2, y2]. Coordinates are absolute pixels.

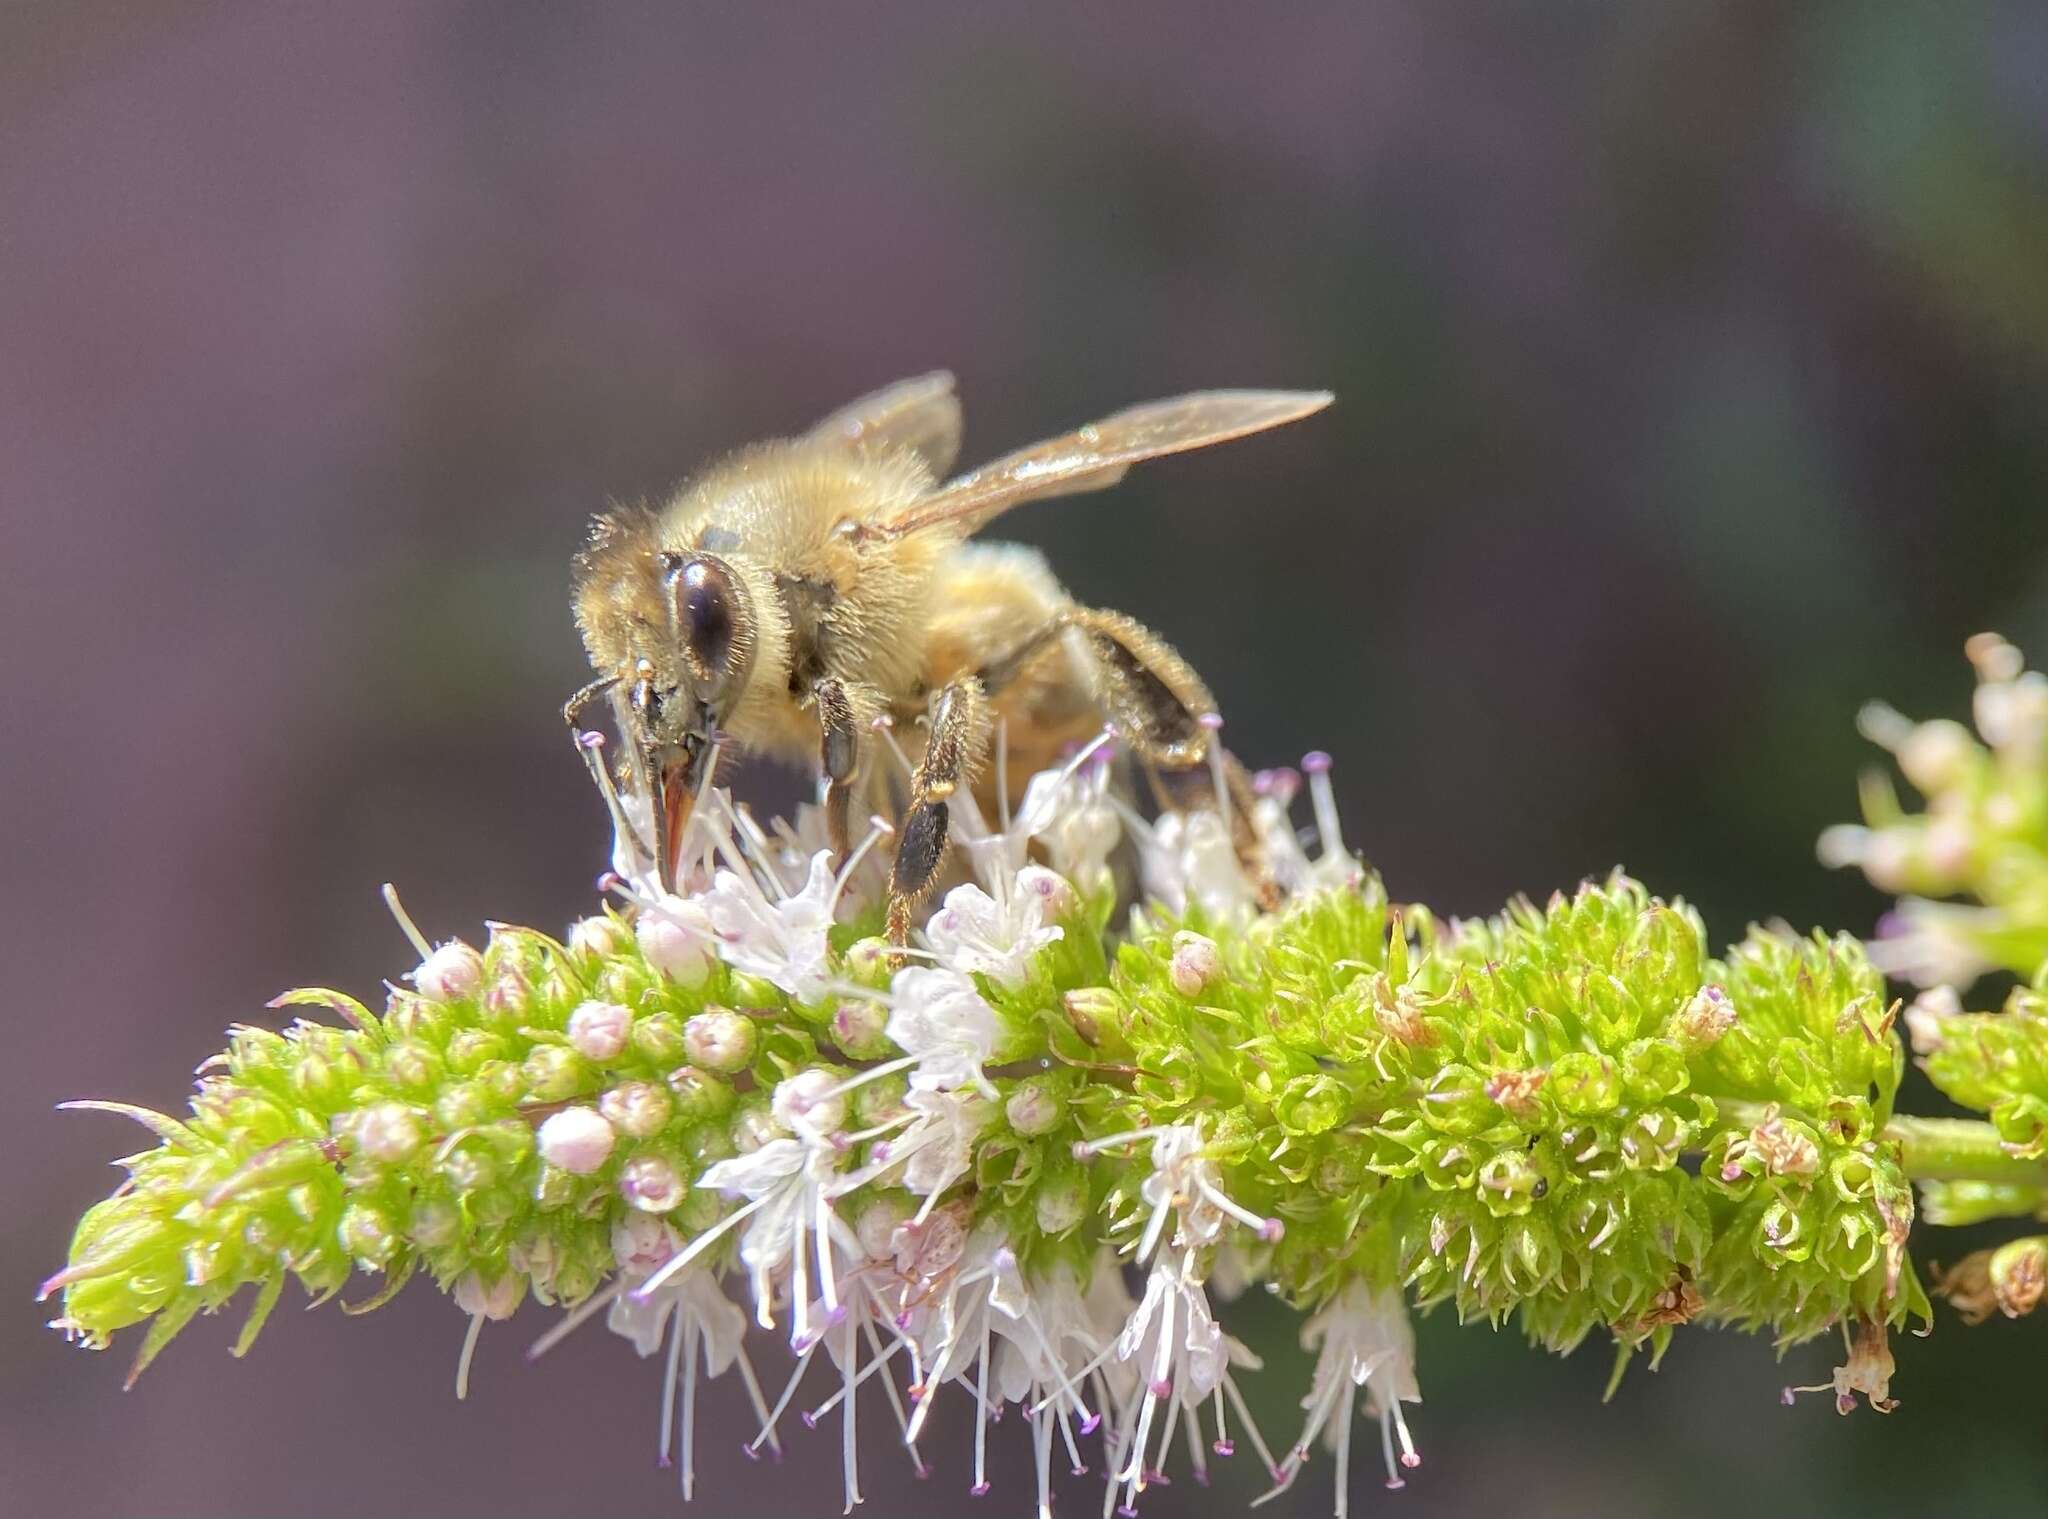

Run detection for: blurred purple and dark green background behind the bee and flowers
[[0, 0, 2048, 1519]]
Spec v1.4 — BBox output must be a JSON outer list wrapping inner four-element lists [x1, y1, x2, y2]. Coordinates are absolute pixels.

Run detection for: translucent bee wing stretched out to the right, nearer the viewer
[[874, 391, 1331, 536]]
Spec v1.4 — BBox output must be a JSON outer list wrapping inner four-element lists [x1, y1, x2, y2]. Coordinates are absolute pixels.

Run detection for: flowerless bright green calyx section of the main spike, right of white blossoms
[[1089, 876, 1925, 1349]]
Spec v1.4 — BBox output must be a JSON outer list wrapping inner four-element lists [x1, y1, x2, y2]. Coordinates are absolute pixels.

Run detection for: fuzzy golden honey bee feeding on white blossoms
[[563, 373, 1331, 944]]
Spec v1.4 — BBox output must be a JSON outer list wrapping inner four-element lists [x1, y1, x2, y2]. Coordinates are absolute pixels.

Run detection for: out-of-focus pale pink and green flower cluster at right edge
[[1819, 633, 2048, 987]]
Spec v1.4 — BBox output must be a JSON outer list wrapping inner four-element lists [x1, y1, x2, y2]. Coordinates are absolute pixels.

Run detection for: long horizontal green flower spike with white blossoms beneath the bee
[[45, 739, 2048, 1519]]
